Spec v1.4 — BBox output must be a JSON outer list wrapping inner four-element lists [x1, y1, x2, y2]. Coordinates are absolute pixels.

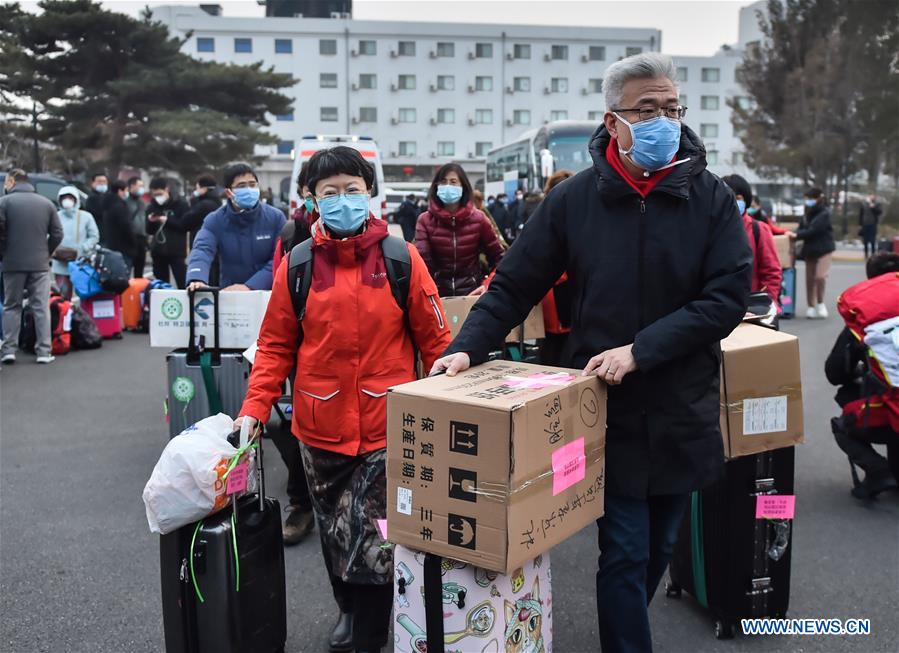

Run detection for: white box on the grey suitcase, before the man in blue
[[150, 290, 271, 349]]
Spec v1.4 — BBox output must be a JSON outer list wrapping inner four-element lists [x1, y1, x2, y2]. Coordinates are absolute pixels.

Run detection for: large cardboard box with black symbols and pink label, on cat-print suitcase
[[387, 361, 606, 574]]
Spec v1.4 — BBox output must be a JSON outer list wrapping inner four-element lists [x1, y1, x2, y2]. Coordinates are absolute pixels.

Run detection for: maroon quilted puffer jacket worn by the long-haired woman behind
[[415, 200, 503, 297]]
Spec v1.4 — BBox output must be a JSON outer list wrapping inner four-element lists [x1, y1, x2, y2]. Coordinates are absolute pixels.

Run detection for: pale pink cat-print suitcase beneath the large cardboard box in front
[[393, 545, 553, 653]]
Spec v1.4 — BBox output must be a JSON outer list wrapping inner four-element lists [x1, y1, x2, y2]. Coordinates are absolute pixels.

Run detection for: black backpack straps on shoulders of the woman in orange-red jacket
[[287, 236, 412, 338]]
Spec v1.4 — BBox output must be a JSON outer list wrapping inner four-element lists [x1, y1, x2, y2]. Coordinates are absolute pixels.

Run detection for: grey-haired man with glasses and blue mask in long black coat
[[432, 53, 751, 651]]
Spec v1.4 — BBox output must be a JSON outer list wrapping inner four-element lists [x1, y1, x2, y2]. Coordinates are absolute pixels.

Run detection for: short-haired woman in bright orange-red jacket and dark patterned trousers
[[235, 147, 450, 653]]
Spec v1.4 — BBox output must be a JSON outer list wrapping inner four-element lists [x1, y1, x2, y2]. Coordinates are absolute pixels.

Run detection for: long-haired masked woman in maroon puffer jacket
[[415, 163, 504, 296]]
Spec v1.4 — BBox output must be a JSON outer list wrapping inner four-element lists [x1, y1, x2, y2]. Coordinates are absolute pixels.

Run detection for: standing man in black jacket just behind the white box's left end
[[147, 177, 189, 288]]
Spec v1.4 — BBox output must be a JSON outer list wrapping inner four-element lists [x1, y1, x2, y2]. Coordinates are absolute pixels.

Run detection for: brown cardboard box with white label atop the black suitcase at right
[[721, 324, 804, 458]]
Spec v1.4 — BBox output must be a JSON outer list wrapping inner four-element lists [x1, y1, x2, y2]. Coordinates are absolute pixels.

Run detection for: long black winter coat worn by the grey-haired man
[[447, 126, 752, 498]]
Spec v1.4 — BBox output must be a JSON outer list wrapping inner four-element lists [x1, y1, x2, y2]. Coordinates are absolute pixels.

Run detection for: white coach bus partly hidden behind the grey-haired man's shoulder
[[484, 120, 600, 197]]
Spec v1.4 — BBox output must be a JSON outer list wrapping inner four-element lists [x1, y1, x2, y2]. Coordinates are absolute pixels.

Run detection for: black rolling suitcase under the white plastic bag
[[160, 430, 287, 653]]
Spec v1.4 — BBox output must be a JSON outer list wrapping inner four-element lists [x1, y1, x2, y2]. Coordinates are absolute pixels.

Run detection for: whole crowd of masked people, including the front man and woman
[[0, 53, 895, 653]]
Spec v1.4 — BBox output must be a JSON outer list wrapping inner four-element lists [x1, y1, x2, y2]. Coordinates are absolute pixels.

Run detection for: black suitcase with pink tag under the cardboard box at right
[[666, 447, 795, 639]]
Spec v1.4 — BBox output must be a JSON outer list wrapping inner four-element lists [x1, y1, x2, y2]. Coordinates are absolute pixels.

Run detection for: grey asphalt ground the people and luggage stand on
[[0, 264, 899, 653]]
